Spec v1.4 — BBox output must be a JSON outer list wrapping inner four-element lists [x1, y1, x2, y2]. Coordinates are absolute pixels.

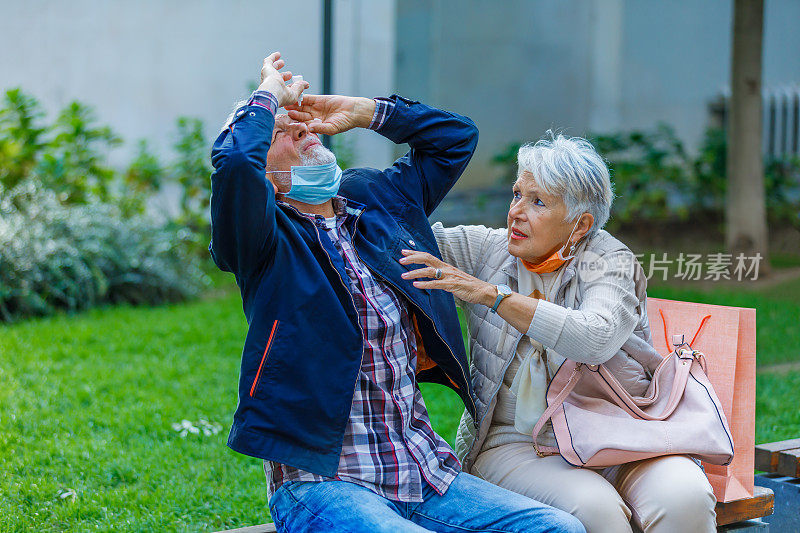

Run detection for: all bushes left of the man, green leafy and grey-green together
[[0, 88, 219, 321]]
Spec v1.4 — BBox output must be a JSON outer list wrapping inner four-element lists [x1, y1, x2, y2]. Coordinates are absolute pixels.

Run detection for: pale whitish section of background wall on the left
[[0, 0, 395, 165]]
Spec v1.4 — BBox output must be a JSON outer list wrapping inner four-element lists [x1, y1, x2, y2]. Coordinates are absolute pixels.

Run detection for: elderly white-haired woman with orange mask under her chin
[[400, 134, 716, 533]]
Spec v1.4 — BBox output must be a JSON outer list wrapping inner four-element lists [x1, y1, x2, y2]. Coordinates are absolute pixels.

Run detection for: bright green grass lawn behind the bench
[[0, 272, 800, 531]]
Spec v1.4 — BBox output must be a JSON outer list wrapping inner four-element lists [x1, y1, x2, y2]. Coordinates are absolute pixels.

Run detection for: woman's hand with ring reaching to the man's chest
[[399, 250, 497, 306]]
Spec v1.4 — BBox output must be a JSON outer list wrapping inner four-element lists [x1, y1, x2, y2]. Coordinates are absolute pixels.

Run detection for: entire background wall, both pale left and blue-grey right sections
[[0, 0, 800, 190]]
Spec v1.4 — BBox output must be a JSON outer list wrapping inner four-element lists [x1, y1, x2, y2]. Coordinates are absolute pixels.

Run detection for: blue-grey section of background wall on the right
[[397, 0, 800, 187]]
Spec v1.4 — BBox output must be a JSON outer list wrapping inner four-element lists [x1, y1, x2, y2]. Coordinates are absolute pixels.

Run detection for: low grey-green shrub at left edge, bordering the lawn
[[0, 179, 207, 321]]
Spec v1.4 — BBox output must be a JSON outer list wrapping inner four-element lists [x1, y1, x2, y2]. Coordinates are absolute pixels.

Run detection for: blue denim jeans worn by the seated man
[[269, 472, 585, 533]]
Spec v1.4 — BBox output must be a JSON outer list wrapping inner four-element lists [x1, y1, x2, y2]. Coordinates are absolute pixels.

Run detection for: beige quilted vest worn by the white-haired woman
[[433, 222, 661, 472]]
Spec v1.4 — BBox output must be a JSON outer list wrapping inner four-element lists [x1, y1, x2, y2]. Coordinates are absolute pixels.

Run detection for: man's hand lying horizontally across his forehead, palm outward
[[286, 94, 375, 135]]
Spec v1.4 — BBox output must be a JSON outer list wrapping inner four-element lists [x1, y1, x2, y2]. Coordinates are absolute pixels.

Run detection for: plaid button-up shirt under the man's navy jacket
[[264, 190, 461, 502]]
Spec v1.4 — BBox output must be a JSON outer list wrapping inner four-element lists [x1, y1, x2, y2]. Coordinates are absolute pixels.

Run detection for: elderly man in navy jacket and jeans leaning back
[[210, 52, 583, 533]]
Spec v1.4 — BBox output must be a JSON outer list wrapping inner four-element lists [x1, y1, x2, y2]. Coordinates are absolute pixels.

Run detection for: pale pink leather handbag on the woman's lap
[[533, 317, 733, 468]]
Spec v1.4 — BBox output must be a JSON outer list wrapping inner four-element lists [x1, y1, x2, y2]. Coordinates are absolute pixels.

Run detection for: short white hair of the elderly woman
[[517, 130, 614, 237]]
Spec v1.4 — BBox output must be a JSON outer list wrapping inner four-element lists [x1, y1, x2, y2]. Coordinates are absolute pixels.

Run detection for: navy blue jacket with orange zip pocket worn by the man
[[209, 95, 478, 476]]
